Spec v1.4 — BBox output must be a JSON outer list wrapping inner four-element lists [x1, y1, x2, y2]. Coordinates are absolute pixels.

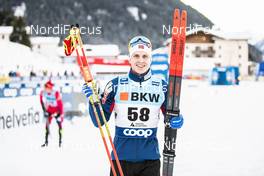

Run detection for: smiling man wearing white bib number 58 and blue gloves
[[83, 36, 183, 176]]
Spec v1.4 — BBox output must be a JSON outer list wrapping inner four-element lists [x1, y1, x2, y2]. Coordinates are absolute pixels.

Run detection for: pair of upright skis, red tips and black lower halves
[[162, 9, 187, 176]]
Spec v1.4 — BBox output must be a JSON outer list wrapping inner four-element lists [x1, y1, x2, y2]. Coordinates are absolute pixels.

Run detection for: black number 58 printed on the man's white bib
[[127, 107, 150, 122]]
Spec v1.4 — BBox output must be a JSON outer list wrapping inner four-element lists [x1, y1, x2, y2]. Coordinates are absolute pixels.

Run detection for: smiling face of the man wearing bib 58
[[129, 51, 151, 74]]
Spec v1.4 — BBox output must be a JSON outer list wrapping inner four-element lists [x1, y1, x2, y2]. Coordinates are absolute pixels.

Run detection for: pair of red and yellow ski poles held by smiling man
[[64, 25, 124, 176]]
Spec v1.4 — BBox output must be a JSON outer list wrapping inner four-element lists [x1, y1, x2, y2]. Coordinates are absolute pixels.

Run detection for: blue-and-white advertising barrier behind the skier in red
[[0, 78, 88, 118]]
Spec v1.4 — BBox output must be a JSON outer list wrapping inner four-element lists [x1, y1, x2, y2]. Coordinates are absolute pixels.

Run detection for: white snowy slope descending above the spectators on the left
[[0, 41, 79, 75]]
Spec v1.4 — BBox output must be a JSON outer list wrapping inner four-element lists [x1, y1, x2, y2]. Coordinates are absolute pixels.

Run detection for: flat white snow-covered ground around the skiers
[[0, 80, 264, 176]]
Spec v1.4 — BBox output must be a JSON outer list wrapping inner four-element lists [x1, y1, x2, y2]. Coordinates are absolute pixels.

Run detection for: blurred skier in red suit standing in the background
[[40, 80, 64, 147]]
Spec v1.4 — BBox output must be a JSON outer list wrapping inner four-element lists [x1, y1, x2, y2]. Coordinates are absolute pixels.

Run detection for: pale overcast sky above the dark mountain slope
[[182, 0, 264, 40]]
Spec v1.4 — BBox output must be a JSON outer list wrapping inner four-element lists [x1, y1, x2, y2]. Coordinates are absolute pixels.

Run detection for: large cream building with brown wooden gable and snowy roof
[[185, 28, 250, 75]]
